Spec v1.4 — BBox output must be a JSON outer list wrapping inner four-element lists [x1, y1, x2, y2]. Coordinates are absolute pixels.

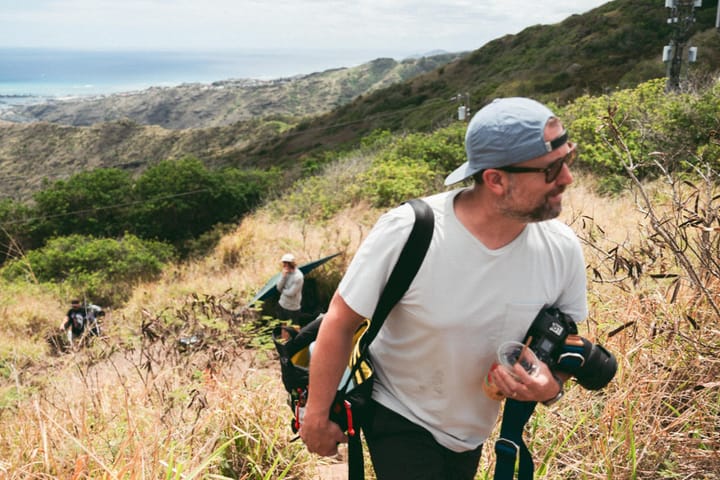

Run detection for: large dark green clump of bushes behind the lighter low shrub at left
[[19, 158, 280, 254]]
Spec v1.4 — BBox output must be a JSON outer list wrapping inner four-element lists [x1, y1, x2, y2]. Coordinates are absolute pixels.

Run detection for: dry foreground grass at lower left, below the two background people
[[0, 290, 324, 479]]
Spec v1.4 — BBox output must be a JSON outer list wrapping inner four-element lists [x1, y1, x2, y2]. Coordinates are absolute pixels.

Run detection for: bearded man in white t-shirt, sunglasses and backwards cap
[[300, 98, 587, 480]]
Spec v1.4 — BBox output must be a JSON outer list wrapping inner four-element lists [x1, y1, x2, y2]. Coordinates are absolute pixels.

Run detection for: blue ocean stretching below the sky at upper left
[[0, 48, 389, 108]]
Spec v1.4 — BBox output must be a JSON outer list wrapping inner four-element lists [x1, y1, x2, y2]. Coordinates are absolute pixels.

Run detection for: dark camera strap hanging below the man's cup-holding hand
[[493, 398, 537, 480]]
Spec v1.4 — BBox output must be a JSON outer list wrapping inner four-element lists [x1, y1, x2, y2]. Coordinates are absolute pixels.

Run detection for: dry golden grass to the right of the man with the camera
[[532, 174, 720, 479]]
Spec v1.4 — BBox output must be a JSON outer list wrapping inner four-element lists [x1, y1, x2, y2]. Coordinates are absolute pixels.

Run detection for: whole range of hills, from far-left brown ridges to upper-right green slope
[[0, 0, 720, 198]]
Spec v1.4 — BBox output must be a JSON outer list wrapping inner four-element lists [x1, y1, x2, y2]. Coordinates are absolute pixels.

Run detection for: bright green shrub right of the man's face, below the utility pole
[[560, 78, 720, 179]]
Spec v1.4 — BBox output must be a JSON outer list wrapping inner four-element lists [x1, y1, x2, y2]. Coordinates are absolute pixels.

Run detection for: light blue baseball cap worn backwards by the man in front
[[445, 97, 567, 185]]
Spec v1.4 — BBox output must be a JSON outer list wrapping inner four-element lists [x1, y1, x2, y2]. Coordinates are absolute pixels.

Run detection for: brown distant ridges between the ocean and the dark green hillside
[[0, 53, 463, 200]]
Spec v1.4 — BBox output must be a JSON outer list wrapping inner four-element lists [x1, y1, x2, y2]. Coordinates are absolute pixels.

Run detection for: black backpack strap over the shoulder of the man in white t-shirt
[[348, 199, 435, 480]]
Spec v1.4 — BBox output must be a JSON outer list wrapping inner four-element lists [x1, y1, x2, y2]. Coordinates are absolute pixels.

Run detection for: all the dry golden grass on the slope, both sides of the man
[[0, 171, 720, 479]]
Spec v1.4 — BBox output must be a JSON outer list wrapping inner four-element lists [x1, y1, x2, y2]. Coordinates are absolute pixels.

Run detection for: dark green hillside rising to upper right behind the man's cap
[[245, 0, 720, 165]]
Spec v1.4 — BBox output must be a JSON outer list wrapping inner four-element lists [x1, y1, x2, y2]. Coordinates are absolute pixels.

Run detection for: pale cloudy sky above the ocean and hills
[[0, 0, 608, 57]]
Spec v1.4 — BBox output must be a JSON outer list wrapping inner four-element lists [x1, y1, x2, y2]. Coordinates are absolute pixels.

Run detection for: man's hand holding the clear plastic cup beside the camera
[[491, 362, 560, 402]]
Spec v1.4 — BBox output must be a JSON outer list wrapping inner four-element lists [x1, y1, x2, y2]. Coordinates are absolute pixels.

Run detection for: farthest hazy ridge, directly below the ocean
[[0, 52, 463, 129]]
